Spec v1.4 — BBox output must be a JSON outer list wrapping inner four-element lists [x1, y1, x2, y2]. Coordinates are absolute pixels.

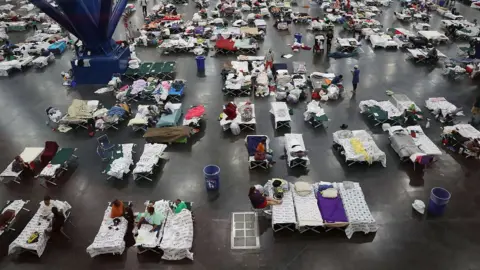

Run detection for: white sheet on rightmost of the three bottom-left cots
[[160, 209, 193, 261]]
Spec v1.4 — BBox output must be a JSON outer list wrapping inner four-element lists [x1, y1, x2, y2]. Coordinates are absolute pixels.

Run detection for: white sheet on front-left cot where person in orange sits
[[87, 206, 128, 258]]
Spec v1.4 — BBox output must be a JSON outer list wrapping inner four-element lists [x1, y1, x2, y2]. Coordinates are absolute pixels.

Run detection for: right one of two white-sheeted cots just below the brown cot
[[132, 144, 167, 181]]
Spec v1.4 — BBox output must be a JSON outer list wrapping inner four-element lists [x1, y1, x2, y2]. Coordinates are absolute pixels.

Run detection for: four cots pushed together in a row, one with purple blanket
[[254, 179, 378, 239]]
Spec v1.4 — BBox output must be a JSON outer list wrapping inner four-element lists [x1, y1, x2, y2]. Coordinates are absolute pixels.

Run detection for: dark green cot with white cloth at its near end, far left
[[35, 148, 78, 187]]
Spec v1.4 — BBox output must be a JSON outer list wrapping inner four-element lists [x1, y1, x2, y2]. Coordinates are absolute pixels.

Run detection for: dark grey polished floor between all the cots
[[0, 2, 480, 270]]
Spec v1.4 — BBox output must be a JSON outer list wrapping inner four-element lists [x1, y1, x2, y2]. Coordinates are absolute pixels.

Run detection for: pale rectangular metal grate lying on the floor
[[231, 212, 260, 249]]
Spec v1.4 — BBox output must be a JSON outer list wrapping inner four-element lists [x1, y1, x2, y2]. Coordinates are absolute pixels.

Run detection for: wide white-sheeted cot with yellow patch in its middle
[[333, 130, 387, 167]]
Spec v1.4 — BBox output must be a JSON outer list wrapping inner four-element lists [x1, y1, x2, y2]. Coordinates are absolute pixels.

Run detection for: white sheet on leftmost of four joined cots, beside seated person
[[265, 180, 297, 227]]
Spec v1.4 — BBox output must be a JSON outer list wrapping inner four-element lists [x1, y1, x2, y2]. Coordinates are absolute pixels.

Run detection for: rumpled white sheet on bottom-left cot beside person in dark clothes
[[8, 201, 72, 257]]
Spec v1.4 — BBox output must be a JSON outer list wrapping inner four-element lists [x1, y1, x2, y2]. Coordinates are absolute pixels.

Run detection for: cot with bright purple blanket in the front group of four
[[315, 182, 348, 232]]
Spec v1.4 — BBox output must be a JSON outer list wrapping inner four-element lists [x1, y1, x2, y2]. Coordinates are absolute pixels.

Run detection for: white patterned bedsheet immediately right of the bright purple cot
[[333, 183, 378, 239]]
